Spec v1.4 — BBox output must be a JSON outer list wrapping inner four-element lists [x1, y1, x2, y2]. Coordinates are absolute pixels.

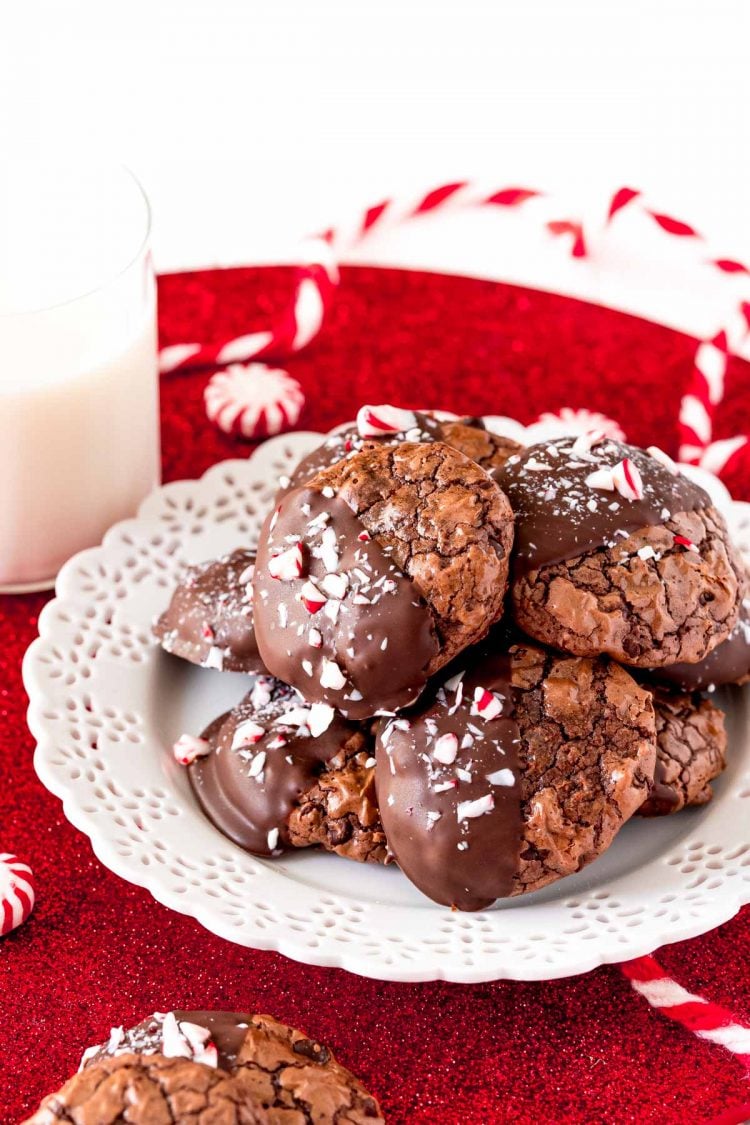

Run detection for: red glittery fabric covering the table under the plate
[[0, 268, 750, 1125]]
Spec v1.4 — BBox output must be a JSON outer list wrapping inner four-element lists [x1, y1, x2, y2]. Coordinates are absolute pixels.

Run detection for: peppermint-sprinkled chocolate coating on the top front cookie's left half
[[254, 478, 440, 719]]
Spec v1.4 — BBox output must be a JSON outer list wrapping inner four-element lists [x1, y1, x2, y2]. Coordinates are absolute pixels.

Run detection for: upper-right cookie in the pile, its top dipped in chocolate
[[498, 435, 742, 667]]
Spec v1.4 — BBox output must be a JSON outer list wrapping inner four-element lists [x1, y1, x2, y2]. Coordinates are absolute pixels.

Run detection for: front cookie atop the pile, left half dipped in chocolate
[[253, 442, 513, 719]]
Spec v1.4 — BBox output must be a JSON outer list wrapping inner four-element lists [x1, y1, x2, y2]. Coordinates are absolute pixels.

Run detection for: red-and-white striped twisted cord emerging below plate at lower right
[[620, 956, 750, 1077]]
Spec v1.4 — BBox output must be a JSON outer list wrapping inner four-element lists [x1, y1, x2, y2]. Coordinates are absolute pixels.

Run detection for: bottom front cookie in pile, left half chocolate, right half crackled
[[376, 645, 656, 910]]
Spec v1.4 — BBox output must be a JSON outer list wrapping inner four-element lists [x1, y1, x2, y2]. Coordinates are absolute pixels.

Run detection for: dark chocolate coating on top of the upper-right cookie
[[497, 438, 711, 575]]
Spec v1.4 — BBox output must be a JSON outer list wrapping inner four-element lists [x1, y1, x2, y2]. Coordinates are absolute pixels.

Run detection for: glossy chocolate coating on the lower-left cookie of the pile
[[189, 676, 369, 855]]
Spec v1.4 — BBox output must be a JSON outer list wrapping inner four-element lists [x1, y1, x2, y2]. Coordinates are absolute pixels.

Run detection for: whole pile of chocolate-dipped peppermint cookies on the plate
[[156, 406, 750, 910]]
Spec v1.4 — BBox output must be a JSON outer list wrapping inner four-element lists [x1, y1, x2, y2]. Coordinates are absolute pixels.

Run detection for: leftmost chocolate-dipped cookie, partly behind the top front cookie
[[154, 549, 265, 672]]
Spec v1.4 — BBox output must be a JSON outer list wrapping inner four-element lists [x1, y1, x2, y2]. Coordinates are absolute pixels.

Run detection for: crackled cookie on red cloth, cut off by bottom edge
[[27, 1011, 382, 1125]]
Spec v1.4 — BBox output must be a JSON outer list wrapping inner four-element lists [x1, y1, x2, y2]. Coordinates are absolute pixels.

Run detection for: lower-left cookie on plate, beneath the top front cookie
[[189, 676, 386, 862]]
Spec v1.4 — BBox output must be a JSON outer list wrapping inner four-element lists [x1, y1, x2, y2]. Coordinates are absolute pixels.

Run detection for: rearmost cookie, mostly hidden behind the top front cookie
[[282, 407, 522, 492]]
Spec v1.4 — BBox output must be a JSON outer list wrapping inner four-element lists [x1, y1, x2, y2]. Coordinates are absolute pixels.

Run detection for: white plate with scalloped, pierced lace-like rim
[[24, 433, 750, 982]]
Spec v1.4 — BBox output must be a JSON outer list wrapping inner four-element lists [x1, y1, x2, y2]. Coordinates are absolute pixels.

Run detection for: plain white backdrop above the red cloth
[[0, 0, 750, 269]]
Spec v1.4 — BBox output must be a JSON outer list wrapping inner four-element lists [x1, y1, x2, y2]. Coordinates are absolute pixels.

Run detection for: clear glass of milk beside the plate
[[0, 162, 160, 593]]
